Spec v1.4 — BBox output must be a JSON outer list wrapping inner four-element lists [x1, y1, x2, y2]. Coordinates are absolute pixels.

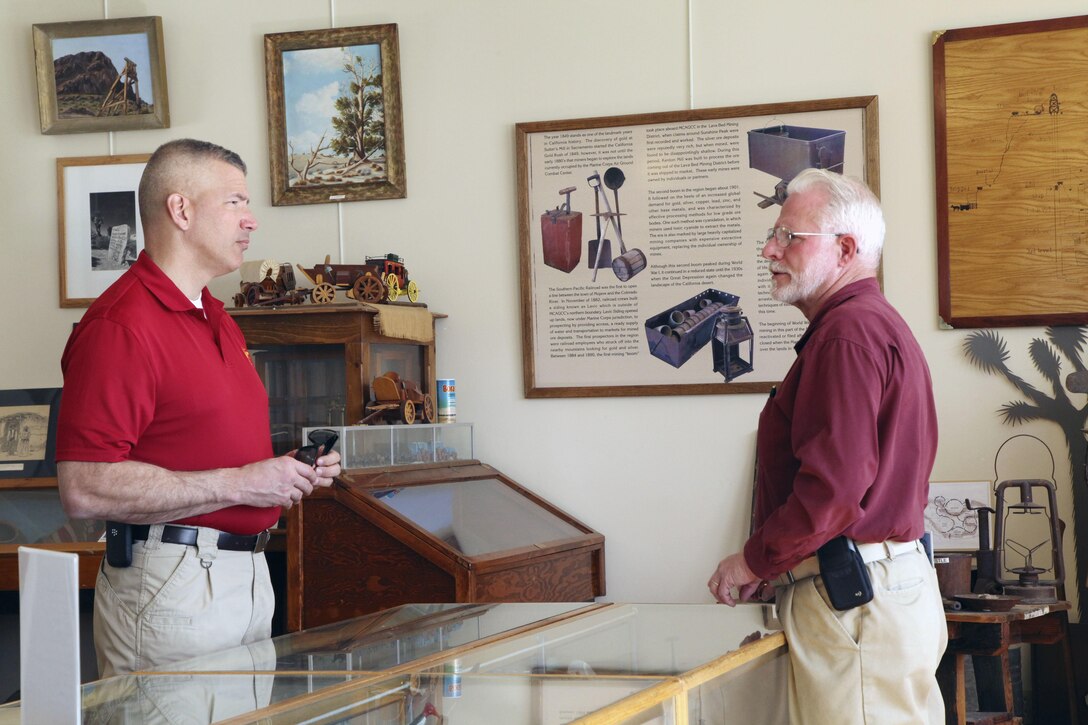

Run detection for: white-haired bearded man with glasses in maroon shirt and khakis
[[707, 170, 948, 725]]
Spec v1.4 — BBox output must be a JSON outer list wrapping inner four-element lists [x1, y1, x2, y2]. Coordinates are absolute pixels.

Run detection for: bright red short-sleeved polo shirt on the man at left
[[57, 253, 280, 534]]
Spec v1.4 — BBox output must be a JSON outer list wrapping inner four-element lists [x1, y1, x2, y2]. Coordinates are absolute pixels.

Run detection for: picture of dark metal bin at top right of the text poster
[[747, 124, 846, 209]]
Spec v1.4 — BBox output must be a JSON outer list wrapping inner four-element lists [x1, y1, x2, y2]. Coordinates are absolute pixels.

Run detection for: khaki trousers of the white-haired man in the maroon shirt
[[778, 551, 948, 725]]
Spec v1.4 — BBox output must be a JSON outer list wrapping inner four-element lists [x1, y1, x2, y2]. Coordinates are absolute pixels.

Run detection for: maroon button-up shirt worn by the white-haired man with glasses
[[744, 279, 937, 579]]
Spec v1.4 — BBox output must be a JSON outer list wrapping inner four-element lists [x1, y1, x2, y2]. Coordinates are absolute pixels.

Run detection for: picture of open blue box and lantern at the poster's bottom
[[645, 290, 754, 382]]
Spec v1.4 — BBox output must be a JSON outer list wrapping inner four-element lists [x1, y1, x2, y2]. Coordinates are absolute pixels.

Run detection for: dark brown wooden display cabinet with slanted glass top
[[286, 460, 605, 631]]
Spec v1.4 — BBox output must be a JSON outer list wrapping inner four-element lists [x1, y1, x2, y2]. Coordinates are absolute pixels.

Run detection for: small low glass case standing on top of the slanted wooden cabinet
[[298, 422, 475, 470]]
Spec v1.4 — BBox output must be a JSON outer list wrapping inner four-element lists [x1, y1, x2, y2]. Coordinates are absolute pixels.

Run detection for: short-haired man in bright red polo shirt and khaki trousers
[[57, 139, 339, 677]]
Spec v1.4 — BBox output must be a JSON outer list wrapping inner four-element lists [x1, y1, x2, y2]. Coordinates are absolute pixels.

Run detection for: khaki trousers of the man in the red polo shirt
[[94, 525, 275, 677]]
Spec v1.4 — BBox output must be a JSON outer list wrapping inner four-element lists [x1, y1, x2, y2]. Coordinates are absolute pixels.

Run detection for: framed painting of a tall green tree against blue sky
[[264, 24, 408, 206]]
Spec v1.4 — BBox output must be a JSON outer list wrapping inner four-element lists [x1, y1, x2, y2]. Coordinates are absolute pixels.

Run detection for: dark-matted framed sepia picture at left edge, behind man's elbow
[[0, 388, 61, 478]]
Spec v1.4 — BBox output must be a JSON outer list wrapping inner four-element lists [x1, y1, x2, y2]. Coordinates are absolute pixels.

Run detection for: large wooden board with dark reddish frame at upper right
[[932, 15, 1088, 328]]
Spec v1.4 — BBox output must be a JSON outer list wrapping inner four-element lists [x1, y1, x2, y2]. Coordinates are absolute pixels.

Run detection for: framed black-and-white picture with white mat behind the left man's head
[[57, 153, 150, 307]]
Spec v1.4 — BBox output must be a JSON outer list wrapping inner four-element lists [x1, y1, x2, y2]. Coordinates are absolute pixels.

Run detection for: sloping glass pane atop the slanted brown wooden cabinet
[[370, 478, 583, 556]]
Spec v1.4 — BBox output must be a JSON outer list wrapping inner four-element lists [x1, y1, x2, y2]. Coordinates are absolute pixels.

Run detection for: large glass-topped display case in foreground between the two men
[[0, 603, 787, 725]]
